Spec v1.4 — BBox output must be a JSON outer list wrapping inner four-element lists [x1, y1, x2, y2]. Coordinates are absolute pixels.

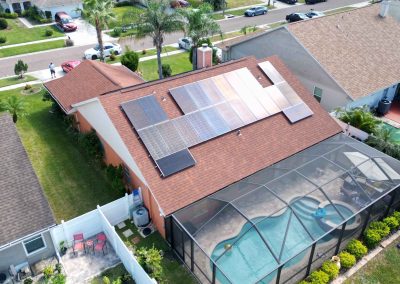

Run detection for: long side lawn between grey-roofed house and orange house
[[0, 89, 122, 222]]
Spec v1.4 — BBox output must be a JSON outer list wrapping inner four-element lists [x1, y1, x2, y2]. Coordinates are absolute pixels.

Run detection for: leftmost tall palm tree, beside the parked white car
[[79, 0, 115, 62]]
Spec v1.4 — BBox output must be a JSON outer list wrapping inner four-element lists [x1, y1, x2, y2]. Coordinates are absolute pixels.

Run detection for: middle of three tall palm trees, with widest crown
[[136, 0, 183, 79]]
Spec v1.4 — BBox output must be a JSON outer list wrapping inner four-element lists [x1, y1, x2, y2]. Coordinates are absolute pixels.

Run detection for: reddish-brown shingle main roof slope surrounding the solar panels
[[100, 57, 341, 215]]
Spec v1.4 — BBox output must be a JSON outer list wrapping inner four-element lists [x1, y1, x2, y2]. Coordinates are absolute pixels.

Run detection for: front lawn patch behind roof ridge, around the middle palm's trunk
[[138, 52, 192, 81]]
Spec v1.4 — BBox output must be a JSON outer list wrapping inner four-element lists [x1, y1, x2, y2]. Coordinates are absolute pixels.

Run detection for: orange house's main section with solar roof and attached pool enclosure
[[46, 52, 400, 283]]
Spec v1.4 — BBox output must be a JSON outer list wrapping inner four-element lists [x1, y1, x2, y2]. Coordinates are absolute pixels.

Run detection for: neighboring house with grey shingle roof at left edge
[[0, 114, 56, 283]]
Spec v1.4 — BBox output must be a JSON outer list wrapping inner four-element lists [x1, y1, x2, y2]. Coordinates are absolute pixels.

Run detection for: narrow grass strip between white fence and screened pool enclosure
[[115, 220, 197, 284]]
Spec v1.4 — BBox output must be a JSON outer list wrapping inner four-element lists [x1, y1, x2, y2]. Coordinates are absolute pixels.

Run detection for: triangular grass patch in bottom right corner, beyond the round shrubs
[[345, 236, 400, 284]]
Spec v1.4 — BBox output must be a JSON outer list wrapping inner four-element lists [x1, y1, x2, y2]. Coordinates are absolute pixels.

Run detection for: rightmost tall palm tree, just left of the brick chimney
[[180, 4, 221, 70]]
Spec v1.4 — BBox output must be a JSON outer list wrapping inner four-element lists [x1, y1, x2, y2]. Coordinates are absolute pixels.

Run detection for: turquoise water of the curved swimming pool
[[211, 198, 354, 283]]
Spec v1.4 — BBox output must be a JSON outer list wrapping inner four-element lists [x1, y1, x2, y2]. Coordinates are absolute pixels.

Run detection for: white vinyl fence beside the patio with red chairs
[[50, 194, 157, 284]]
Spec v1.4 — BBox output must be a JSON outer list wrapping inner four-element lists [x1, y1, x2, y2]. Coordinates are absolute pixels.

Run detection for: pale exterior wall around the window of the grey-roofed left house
[[0, 231, 56, 271]]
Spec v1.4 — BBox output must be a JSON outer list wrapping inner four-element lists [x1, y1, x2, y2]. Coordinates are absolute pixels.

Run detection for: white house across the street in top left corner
[[0, 0, 83, 17]]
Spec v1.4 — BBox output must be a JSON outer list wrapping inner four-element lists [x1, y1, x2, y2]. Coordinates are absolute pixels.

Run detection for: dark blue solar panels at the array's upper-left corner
[[121, 95, 168, 130]]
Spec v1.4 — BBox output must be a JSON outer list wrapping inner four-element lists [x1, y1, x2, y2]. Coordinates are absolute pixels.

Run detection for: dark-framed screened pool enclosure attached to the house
[[166, 134, 400, 283]]
